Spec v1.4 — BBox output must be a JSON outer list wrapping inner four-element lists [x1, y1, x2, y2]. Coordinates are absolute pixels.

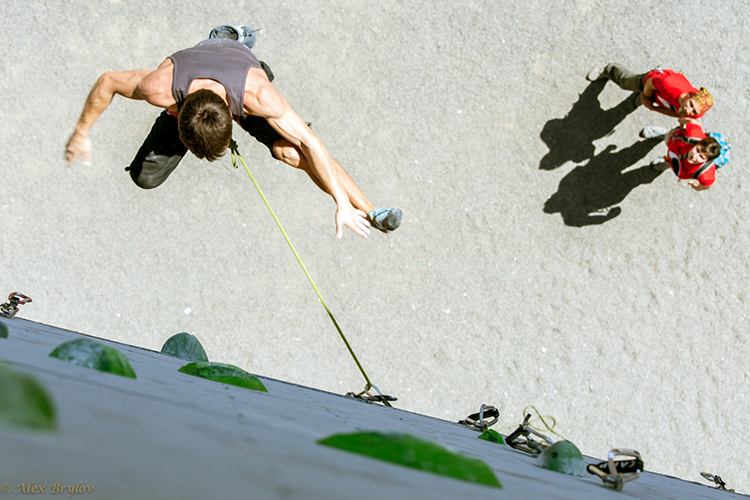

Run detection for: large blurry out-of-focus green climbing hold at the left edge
[[0, 363, 57, 430]]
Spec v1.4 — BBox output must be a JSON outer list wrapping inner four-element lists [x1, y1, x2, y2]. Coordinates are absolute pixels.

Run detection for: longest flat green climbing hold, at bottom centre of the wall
[[318, 432, 502, 488]]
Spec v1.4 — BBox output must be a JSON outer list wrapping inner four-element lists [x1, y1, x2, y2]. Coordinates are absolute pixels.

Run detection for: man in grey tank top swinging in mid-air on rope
[[65, 27, 402, 238]]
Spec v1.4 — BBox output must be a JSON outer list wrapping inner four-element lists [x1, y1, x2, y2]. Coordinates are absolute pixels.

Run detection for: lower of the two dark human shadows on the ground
[[544, 139, 661, 227]]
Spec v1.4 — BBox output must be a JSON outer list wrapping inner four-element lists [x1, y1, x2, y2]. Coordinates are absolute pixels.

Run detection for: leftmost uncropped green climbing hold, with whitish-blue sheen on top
[[50, 338, 135, 378]]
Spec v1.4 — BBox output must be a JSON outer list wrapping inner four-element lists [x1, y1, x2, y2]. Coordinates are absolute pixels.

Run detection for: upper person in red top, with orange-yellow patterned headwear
[[586, 64, 714, 125]]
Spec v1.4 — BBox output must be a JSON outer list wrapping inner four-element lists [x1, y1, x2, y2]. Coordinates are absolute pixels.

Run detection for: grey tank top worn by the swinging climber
[[169, 38, 261, 118]]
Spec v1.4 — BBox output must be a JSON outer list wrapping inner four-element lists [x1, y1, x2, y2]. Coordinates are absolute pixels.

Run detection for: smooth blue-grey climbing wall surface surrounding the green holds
[[0, 318, 740, 500]]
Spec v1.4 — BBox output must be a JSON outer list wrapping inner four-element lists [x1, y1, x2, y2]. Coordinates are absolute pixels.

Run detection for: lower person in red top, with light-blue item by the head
[[641, 122, 721, 191]]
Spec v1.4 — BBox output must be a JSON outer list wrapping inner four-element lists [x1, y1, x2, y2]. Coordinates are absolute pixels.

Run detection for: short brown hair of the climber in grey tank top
[[177, 89, 232, 161]]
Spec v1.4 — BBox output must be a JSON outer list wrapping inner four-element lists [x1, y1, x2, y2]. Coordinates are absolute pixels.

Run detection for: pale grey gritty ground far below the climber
[[0, 0, 750, 492]]
